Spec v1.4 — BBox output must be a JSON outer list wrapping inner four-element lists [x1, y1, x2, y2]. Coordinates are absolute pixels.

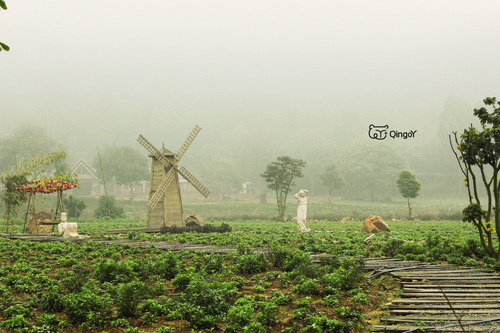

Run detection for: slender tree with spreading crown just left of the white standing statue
[[261, 156, 306, 219]]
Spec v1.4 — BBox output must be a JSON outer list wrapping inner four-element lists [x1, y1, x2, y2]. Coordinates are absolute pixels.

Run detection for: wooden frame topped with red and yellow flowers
[[17, 179, 78, 230]]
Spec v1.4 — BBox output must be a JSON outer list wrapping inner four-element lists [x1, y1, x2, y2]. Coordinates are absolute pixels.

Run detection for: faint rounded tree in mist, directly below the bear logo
[[339, 142, 407, 201]]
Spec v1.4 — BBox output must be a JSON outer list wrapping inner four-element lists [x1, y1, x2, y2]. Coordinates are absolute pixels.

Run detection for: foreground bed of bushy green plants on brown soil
[[0, 234, 386, 332]]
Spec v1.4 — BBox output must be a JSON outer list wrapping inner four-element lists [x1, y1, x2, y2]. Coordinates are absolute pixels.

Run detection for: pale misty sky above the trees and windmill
[[0, 0, 500, 199]]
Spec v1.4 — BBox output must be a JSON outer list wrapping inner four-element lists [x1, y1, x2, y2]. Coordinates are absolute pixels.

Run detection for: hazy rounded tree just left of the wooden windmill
[[93, 146, 149, 196]]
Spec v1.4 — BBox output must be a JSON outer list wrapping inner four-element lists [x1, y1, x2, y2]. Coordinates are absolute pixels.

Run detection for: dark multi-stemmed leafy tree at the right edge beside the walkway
[[449, 97, 500, 261]]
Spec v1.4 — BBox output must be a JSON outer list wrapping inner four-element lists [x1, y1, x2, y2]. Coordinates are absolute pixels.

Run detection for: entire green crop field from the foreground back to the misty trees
[[0, 198, 492, 332]]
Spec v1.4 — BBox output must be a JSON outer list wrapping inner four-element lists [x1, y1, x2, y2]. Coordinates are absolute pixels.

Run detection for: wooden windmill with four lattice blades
[[137, 125, 210, 229]]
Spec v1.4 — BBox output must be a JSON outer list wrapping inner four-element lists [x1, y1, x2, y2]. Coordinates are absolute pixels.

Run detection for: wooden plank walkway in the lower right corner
[[366, 258, 500, 333]]
